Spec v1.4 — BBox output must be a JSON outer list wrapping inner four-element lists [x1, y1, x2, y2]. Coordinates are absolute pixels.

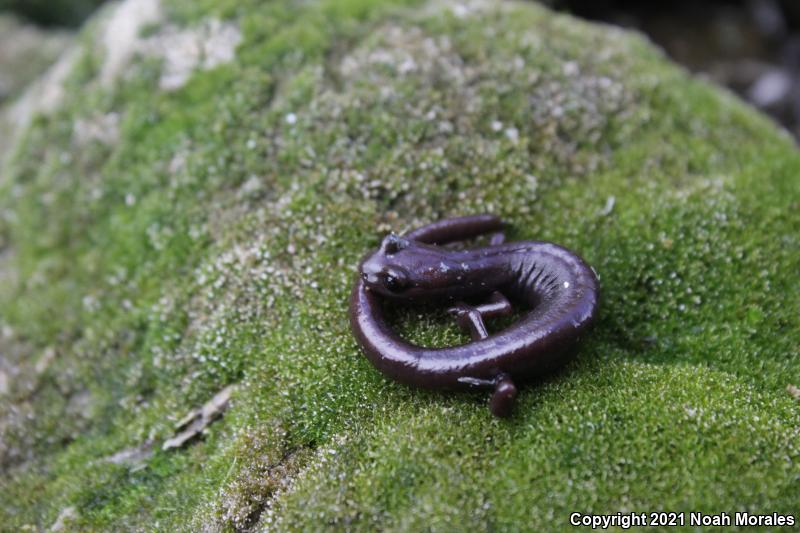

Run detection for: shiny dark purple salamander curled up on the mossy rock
[[350, 215, 598, 416]]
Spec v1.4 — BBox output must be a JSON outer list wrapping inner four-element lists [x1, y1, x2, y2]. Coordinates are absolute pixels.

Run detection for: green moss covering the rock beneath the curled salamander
[[0, 0, 800, 531]]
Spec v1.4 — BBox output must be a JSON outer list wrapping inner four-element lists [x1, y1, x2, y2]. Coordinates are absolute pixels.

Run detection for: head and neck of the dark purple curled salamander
[[359, 234, 485, 299]]
